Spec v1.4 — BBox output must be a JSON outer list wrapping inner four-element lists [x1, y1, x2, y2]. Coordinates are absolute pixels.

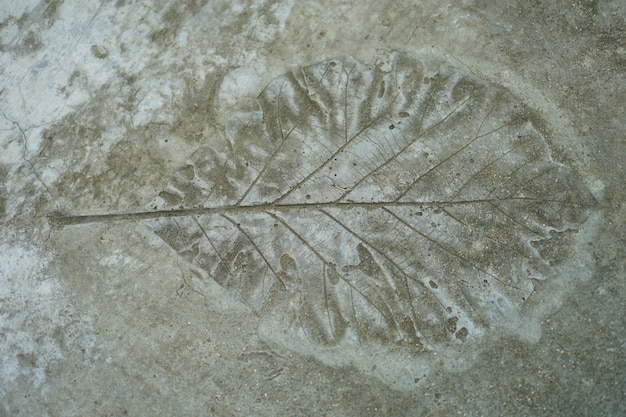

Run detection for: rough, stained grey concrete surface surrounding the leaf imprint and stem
[[0, 0, 626, 416]]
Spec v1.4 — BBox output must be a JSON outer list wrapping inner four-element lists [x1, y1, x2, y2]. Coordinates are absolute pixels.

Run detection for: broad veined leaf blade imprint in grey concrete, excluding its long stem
[[155, 54, 594, 349]]
